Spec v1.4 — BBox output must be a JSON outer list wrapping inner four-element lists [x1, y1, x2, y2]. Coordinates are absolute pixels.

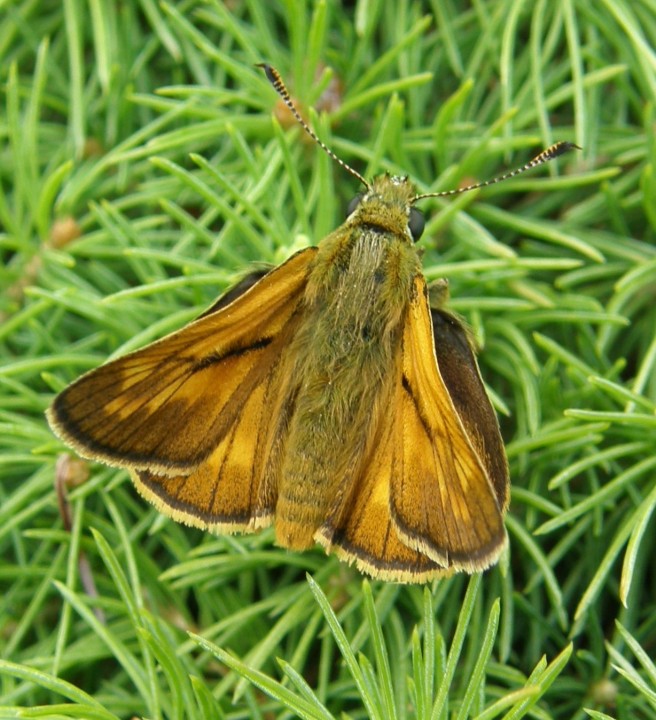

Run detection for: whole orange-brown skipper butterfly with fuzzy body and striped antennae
[[47, 65, 572, 583]]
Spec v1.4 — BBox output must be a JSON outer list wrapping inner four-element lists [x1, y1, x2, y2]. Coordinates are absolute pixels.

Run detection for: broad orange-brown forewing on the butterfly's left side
[[48, 248, 316, 477]]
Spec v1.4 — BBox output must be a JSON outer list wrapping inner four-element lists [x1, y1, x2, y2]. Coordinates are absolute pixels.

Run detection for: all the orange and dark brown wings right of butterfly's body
[[316, 278, 508, 582]]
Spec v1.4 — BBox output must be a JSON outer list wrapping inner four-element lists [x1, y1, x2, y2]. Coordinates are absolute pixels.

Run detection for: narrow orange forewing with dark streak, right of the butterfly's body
[[390, 277, 507, 572]]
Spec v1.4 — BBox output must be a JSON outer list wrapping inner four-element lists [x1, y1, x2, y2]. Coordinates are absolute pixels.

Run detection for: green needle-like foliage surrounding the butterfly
[[0, 0, 656, 720]]
